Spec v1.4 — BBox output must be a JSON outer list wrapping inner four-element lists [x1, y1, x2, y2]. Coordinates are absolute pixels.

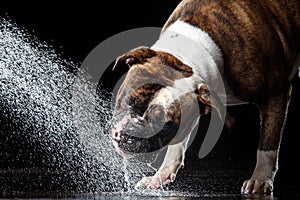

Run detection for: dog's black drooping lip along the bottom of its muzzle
[[119, 122, 179, 153]]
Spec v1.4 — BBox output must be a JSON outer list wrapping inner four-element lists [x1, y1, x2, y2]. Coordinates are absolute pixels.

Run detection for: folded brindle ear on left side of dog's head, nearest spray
[[113, 46, 156, 70]]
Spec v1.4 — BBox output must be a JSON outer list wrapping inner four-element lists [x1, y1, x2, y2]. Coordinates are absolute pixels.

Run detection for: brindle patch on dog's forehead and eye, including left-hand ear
[[115, 47, 193, 116]]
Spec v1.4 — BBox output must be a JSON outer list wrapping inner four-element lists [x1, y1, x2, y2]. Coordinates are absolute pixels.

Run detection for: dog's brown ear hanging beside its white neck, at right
[[198, 84, 225, 119]]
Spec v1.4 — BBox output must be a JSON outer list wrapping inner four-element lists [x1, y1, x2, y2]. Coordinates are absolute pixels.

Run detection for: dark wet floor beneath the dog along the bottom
[[0, 159, 300, 200]]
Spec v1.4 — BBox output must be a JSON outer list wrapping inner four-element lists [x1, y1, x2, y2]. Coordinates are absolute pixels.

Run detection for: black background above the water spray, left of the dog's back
[[0, 0, 179, 62]]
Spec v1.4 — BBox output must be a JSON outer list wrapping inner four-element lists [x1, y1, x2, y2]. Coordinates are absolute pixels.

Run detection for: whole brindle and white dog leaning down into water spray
[[112, 0, 300, 194]]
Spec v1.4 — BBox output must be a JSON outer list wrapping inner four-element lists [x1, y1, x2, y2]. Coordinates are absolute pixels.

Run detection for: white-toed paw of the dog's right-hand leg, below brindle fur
[[241, 179, 273, 194]]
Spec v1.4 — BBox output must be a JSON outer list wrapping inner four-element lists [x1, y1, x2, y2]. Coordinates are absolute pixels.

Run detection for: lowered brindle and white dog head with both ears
[[112, 47, 221, 155]]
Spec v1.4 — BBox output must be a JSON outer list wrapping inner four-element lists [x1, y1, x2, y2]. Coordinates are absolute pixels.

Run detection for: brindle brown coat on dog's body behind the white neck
[[163, 0, 300, 103]]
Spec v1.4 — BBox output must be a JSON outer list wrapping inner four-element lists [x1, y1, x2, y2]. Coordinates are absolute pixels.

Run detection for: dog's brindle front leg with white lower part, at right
[[241, 84, 291, 194]]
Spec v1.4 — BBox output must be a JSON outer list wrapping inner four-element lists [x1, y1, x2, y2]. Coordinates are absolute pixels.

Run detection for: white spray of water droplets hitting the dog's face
[[0, 19, 152, 192]]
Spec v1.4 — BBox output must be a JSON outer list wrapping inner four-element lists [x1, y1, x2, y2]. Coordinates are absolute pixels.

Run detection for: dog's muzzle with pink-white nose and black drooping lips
[[112, 102, 180, 155]]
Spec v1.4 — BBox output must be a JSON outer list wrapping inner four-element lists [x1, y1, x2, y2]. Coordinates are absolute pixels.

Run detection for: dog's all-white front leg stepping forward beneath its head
[[136, 138, 188, 189]]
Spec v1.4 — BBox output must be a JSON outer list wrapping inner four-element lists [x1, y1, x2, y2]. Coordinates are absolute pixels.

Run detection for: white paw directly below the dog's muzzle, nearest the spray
[[135, 173, 176, 189]]
